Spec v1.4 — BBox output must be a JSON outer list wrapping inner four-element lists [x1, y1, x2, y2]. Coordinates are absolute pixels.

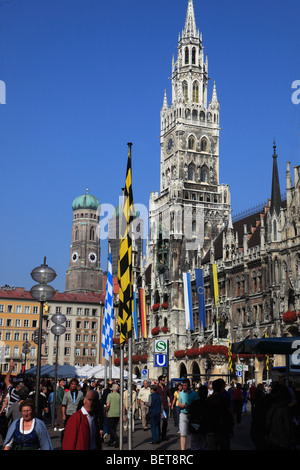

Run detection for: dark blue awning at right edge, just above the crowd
[[231, 336, 300, 355]]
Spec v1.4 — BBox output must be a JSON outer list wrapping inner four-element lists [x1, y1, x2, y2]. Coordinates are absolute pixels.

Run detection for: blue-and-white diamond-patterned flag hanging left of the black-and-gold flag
[[102, 246, 114, 360]]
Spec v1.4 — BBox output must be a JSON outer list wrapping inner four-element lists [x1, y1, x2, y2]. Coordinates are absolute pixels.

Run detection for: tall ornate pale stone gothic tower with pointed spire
[[149, 0, 231, 374]]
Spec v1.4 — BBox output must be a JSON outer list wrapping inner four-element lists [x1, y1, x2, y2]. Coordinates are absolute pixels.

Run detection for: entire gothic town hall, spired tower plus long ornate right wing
[[125, 0, 300, 381]]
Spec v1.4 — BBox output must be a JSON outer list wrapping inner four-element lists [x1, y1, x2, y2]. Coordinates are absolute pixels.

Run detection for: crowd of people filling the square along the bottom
[[0, 362, 300, 451]]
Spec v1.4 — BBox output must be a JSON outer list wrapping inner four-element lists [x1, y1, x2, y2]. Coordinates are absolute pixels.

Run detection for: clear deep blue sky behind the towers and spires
[[0, 0, 300, 291]]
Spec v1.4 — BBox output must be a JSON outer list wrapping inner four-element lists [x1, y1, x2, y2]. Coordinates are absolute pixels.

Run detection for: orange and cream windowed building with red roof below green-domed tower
[[0, 287, 110, 373]]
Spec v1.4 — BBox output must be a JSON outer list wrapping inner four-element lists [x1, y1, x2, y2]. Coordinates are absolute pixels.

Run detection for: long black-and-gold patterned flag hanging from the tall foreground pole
[[118, 143, 134, 346]]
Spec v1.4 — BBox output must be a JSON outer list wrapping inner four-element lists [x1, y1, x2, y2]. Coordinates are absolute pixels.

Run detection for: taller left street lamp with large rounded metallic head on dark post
[[30, 257, 56, 416]]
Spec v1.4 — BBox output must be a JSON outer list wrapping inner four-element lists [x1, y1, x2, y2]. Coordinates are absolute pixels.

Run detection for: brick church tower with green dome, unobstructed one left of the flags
[[66, 190, 103, 293]]
